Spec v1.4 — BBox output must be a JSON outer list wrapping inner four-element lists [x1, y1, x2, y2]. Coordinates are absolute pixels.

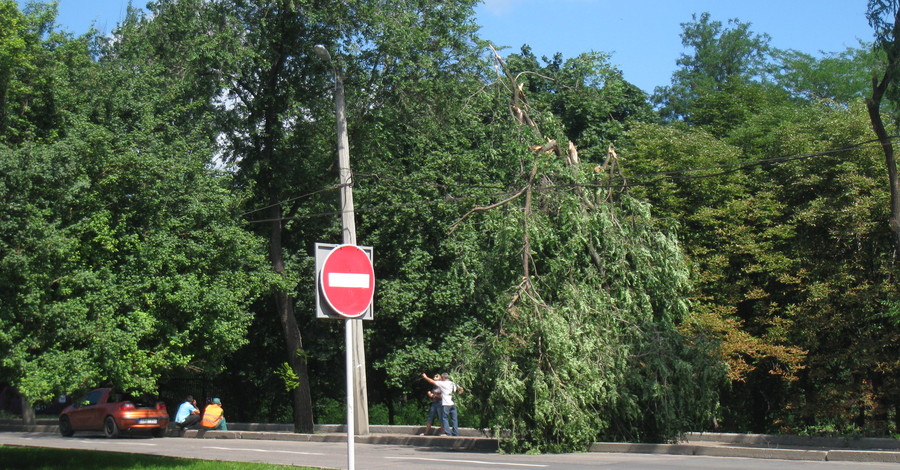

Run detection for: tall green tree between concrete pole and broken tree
[[332, 1, 500, 412]]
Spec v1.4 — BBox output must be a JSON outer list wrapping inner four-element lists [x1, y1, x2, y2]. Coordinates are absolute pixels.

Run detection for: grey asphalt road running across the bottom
[[0, 432, 900, 470]]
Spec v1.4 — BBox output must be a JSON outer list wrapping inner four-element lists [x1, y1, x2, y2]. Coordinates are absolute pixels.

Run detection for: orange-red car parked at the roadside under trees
[[59, 388, 169, 437]]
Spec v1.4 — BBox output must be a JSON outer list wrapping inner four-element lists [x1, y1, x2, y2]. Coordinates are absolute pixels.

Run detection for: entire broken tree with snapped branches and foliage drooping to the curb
[[414, 53, 723, 451]]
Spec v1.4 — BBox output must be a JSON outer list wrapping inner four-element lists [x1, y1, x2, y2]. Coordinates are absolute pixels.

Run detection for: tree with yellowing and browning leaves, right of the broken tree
[[621, 81, 896, 434]]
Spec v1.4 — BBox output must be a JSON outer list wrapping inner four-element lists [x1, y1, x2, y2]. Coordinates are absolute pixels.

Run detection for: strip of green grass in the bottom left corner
[[0, 445, 324, 470]]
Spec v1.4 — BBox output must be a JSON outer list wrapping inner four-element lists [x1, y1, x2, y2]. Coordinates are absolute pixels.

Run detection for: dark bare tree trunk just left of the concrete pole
[[269, 197, 313, 434]]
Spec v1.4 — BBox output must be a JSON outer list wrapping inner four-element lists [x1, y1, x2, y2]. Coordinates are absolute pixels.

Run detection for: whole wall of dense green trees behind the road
[[0, 0, 900, 452]]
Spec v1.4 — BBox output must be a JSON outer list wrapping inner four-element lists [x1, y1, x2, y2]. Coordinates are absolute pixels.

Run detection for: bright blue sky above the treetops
[[38, 0, 872, 92]]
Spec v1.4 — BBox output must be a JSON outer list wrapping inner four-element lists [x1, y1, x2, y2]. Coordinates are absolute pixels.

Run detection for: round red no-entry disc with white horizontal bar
[[319, 245, 375, 318]]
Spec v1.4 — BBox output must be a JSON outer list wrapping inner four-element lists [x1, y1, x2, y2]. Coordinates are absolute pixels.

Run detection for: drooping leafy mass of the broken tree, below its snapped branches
[[467, 186, 723, 452]]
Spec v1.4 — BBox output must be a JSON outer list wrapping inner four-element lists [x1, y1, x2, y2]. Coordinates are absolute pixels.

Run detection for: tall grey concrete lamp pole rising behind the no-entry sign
[[315, 45, 369, 436]]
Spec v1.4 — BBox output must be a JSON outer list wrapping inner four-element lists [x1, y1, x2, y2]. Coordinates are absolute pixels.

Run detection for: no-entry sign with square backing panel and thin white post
[[315, 243, 375, 470]]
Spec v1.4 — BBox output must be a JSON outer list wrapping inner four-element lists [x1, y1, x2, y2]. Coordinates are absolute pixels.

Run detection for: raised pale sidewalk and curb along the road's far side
[[0, 420, 900, 462]]
